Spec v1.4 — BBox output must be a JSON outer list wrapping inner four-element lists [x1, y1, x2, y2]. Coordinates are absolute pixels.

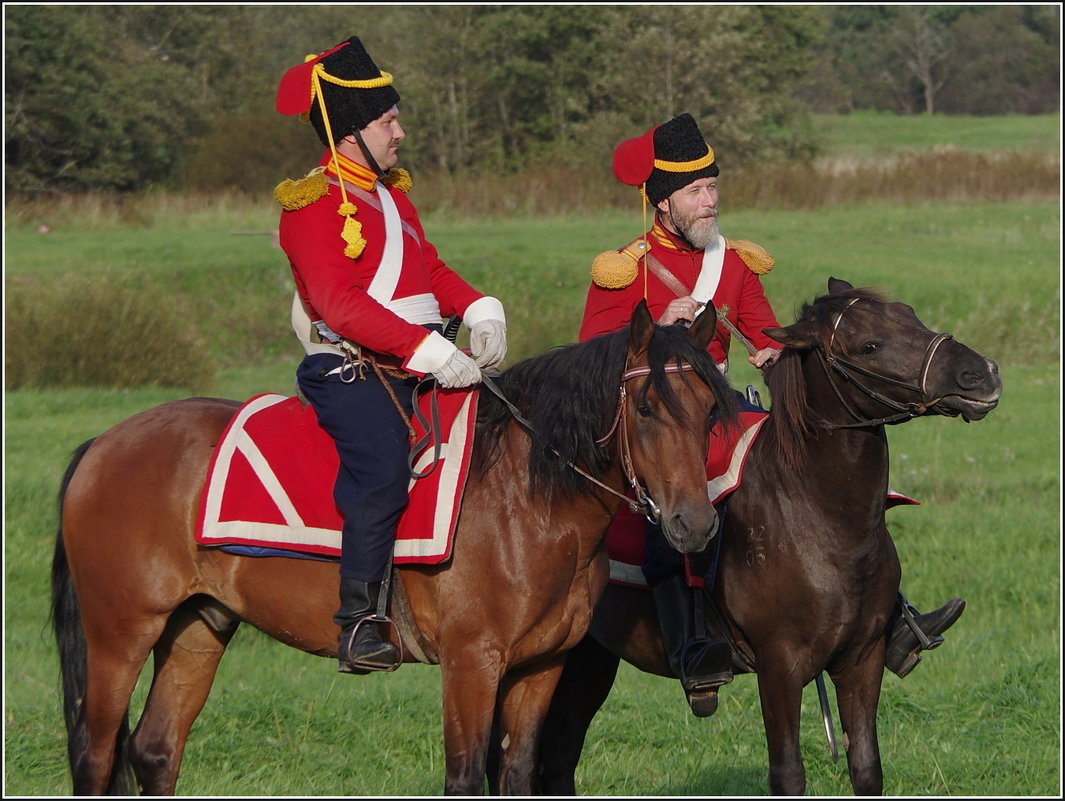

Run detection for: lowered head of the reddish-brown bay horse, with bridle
[[618, 300, 735, 553]]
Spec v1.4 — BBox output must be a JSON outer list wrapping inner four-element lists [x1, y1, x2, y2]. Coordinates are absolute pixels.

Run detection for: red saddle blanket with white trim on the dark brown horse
[[606, 406, 919, 587]]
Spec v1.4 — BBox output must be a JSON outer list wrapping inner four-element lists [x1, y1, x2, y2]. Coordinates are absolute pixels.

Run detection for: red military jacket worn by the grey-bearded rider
[[579, 220, 781, 364]]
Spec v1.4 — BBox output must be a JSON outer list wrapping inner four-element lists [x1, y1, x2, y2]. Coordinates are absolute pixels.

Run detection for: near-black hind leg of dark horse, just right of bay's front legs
[[536, 637, 621, 796]]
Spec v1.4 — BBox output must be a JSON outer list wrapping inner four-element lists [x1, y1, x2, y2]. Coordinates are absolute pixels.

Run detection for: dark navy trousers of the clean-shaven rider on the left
[[296, 354, 417, 582]]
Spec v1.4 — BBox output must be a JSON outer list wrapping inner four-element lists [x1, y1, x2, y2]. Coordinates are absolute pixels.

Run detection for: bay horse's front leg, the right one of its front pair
[[498, 654, 566, 796]]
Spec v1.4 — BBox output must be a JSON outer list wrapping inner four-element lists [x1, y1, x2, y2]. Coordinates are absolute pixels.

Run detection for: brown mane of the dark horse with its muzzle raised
[[763, 287, 885, 470]]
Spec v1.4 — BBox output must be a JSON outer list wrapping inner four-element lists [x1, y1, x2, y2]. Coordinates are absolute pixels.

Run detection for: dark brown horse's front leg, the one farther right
[[832, 649, 884, 796]]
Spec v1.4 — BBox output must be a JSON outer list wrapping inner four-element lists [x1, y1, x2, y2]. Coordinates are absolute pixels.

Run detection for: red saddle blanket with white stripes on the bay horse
[[196, 390, 477, 565]]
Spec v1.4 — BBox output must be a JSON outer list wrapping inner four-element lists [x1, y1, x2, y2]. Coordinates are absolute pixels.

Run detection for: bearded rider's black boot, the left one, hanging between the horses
[[651, 575, 733, 718]]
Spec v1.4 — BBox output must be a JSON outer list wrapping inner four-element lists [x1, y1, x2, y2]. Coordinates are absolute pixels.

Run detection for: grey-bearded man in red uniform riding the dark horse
[[579, 114, 965, 714]]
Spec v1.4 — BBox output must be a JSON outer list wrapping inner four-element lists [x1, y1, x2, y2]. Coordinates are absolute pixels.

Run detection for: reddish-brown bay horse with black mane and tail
[[52, 307, 736, 796]]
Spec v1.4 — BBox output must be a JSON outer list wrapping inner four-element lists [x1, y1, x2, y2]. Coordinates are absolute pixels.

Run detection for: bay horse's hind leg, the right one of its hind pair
[[130, 604, 237, 796]]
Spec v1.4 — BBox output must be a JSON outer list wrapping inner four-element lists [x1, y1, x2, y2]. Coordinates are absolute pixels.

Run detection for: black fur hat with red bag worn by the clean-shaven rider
[[277, 36, 399, 145]]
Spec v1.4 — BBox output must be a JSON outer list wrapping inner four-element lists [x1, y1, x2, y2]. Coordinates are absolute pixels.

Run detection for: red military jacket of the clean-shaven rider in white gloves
[[275, 151, 485, 372]]
